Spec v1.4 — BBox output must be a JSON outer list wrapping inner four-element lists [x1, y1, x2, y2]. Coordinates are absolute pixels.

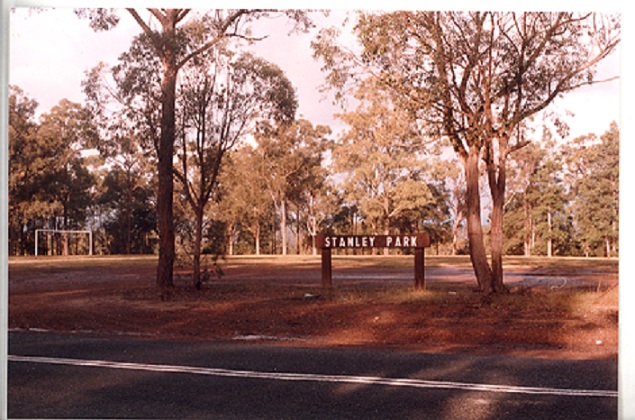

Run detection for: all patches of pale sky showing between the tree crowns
[[10, 8, 620, 142]]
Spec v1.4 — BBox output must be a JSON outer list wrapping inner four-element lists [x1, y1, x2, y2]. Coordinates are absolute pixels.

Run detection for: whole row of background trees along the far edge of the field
[[9, 86, 619, 257]]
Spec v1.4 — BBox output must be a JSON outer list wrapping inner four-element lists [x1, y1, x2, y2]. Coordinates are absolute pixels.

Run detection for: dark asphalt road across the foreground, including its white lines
[[7, 332, 618, 420]]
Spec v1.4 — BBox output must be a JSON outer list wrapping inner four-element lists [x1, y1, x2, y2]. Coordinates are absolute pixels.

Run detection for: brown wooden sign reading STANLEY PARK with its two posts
[[315, 233, 430, 289]]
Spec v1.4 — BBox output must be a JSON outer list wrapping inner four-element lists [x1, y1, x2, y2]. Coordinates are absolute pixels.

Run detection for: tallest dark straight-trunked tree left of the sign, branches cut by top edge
[[77, 8, 310, 292]]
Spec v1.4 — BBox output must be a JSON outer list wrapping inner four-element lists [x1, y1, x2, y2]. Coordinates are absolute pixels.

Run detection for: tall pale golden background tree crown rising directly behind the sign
[[333, 81, 432, 233]]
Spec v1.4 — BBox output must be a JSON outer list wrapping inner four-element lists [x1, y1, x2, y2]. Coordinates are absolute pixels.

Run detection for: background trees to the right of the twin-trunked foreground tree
[[505, 124, 619, 256]]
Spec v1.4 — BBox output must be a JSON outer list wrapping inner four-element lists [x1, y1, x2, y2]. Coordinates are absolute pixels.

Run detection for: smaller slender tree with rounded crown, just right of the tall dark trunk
[[174, 50, 298, 288]]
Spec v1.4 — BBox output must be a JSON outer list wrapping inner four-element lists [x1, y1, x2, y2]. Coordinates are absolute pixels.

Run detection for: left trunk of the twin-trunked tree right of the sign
[[463, 147, 494, 293]]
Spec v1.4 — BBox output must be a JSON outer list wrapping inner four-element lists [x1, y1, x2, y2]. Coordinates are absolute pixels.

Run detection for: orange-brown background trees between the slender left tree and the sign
[[219, 120, 339, 254]]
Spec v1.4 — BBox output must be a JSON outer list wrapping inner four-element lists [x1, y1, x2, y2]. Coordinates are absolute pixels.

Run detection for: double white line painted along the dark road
[[7, 355, 618, 398]]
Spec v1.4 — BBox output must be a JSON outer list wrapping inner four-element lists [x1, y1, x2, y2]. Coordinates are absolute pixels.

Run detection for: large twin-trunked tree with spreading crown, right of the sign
[[314, 11, 620, 293]]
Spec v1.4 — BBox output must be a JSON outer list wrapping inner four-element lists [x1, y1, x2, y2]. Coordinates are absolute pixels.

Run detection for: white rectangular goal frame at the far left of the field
[[35, 229, 93, 256]]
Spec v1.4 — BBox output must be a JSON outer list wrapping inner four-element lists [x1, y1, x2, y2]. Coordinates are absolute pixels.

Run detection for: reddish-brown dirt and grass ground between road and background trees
[[9, 257, 618, 359]]
